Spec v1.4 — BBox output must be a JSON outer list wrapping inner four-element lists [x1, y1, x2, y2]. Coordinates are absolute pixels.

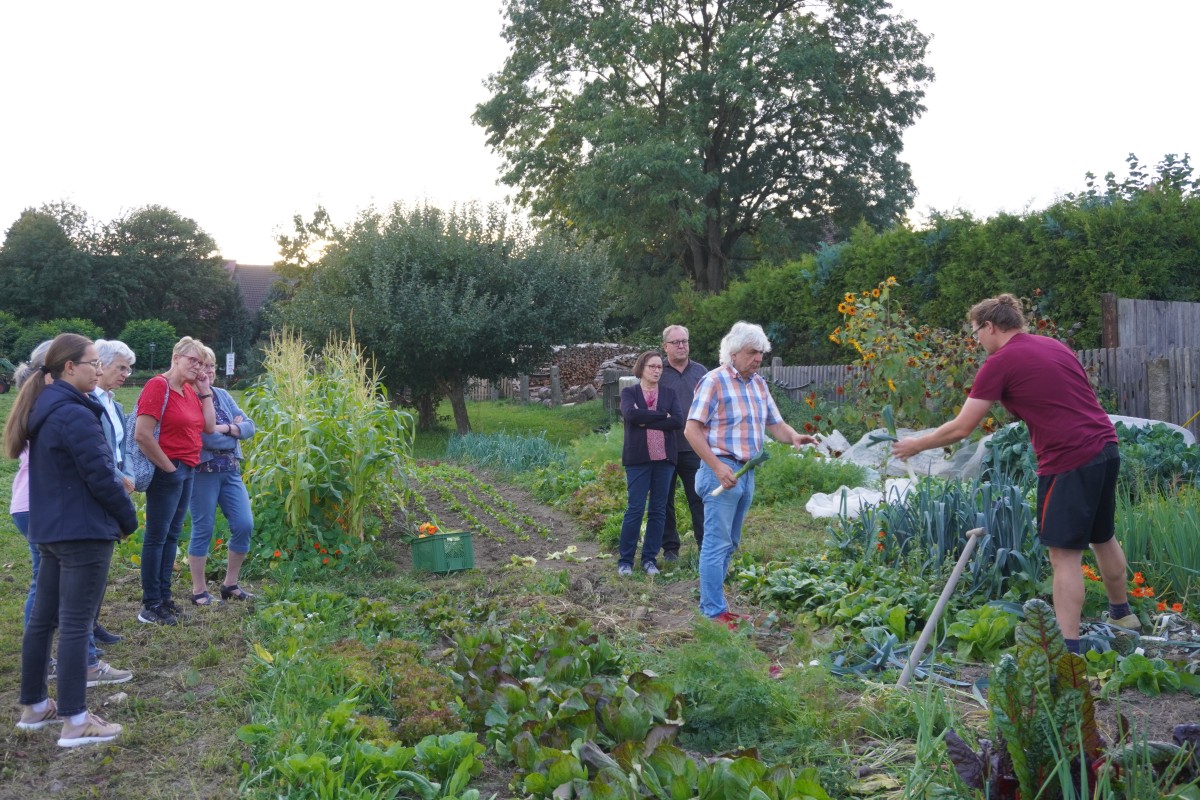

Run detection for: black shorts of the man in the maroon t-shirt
[[1038, 443, 1121, 551]]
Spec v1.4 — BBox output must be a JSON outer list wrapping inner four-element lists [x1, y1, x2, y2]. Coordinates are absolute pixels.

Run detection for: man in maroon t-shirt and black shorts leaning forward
[[892, 294, 1141, 652]]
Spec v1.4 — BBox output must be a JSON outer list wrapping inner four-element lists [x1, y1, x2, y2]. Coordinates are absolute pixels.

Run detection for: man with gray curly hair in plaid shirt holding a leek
[[684, 323, 817, 627]]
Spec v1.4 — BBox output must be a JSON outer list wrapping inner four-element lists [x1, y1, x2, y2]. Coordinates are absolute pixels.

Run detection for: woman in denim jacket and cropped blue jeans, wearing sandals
[[187, 347, 254, 606]]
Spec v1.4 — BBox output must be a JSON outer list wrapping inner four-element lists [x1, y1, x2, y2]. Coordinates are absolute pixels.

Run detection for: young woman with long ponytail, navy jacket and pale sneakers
[[4, 333, 138, 747]]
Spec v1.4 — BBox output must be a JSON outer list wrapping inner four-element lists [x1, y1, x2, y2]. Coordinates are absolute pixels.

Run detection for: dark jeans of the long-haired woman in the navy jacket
[[19, 539, 113, 717]]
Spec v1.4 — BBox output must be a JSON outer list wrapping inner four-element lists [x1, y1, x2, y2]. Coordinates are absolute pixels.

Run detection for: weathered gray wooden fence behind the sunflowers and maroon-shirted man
[[762, 347, 1200, 440]]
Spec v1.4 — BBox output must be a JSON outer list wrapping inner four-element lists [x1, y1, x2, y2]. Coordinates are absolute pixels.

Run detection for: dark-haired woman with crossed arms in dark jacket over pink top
[[617, 350, 684, 576]]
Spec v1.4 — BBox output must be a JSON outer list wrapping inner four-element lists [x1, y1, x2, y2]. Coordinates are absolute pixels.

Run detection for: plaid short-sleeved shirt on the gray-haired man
[[688, 363, 784, 461]]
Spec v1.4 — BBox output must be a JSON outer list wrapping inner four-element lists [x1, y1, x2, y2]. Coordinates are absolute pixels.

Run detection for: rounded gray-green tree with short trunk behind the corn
[[272, 205, 607, 433]]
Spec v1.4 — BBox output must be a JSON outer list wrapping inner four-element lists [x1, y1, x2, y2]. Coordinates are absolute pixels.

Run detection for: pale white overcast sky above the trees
[[0, 0, 1200, 264]]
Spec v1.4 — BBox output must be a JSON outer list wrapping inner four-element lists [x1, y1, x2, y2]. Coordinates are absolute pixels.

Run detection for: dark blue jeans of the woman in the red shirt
[[142, 461, 193, 608]]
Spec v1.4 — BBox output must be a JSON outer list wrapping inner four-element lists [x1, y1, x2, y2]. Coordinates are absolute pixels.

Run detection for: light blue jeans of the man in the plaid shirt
[[696, 458, 754, 616]]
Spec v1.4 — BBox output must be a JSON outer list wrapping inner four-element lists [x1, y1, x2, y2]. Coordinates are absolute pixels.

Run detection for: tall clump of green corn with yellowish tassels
[[246, 330, 413, 564]]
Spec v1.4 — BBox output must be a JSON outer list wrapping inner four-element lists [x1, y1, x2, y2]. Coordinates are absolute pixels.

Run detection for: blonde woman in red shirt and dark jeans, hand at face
[[133, 336, 216, 625]]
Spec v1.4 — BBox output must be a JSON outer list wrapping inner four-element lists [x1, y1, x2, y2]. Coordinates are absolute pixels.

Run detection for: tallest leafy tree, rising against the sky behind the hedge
[[474, 0, 932, 291]]
